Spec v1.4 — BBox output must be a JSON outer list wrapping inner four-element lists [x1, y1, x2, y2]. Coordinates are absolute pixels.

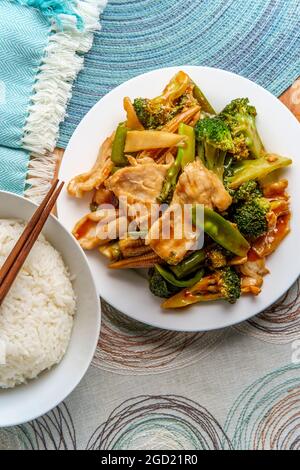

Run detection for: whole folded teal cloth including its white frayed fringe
[[0, 0, 106, 198]]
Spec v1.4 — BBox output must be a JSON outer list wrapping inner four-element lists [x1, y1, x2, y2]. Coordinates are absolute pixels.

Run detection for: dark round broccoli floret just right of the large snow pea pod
[[232, 197, 270, 239]]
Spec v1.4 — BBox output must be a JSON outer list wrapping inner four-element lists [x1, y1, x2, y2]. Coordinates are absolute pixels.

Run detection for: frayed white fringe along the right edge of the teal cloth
[[22, 0, 107, 197]]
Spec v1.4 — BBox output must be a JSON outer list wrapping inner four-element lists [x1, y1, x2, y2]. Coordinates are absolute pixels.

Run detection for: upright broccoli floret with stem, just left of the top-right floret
[[195, 117, 233, 180]]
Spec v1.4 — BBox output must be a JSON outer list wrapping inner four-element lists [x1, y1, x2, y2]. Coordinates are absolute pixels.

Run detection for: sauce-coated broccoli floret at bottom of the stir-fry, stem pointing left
[[162, 266, 241, 308]]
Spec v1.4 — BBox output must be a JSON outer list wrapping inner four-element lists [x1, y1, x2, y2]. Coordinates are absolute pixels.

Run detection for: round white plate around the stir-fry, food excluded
[[58, 66, 300, 331]]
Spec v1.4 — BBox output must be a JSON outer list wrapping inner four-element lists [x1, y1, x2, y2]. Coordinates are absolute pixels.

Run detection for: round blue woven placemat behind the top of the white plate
[[59, 0, 300, 147]]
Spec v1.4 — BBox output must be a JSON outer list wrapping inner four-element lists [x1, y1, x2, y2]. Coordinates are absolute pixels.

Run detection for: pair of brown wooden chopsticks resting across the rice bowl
[[0, 179, 64, 305]]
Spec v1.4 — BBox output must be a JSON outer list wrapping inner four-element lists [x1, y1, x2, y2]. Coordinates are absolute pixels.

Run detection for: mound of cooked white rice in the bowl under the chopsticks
[[0, 219, 76, 388]]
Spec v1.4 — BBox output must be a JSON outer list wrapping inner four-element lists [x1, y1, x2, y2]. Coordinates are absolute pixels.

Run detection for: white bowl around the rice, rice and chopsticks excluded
[[0, 191, 101, 427]]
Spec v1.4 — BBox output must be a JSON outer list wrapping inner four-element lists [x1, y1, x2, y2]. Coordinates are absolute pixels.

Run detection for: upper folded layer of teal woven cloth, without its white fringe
[[0, 0, 49, 148]]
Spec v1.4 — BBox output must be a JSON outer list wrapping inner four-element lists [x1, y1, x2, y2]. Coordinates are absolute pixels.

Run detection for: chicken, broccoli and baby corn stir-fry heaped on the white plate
[[68, 71, 292, 309]]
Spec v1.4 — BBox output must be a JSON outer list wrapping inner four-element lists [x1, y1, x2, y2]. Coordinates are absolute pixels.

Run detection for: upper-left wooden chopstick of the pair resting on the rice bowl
[[0, 179, 58, 285]]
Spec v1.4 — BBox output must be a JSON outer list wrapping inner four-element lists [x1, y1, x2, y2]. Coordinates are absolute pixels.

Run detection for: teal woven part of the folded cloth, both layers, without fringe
[[0, 0, 49, 194]]
